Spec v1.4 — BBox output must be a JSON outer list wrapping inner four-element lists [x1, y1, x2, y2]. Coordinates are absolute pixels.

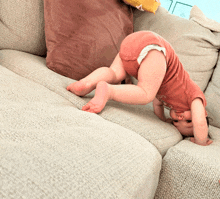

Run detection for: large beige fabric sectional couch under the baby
[[0, 0, 220, 199]]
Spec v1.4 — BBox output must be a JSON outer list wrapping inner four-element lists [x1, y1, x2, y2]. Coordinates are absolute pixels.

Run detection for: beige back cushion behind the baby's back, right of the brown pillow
[[134, 7, 220, 91]]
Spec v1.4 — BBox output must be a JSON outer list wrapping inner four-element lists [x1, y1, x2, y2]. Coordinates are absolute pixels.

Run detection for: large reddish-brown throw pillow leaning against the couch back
[[44, 0, 133, 80]]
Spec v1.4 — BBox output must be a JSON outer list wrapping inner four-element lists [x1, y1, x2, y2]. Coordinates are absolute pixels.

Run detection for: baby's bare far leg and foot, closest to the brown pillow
[[67, 55, 126, 96]]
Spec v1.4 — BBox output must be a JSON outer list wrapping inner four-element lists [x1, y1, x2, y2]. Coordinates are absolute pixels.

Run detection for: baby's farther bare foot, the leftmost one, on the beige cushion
[[66, 81, 93, 96]]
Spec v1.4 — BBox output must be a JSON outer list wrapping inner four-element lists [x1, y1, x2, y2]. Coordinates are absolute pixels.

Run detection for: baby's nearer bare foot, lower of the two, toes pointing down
[[82, 81, 109, 113]]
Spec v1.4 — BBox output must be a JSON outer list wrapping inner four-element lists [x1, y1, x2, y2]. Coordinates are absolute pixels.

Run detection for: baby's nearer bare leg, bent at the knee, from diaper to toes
[[82, 50, 166, 113]]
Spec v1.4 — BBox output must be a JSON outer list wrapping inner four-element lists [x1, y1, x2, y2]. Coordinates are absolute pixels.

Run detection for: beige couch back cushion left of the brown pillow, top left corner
[[0, 0, 46, 55]]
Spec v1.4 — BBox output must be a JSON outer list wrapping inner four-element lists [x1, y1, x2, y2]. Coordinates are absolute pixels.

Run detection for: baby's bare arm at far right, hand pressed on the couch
[[191, 98, 212, 146]]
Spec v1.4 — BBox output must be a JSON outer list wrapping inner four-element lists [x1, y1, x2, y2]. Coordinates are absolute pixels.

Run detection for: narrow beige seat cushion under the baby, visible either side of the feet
[[0, 50, 182, 155]]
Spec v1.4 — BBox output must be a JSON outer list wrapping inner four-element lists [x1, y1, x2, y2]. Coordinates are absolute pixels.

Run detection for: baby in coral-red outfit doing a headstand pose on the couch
[[67, 31, 212, 146]]
